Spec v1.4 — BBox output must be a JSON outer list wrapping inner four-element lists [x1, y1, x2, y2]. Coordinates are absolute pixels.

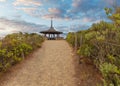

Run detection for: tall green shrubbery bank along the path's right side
[[66, 7, 120, 86]]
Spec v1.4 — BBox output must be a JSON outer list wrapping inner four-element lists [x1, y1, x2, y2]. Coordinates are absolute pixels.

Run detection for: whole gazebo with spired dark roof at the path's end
[[40, 18, 63, 40]]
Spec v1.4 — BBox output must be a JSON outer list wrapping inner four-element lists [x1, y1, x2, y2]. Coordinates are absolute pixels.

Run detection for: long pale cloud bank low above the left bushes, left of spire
[[0, 18, 49, 34]]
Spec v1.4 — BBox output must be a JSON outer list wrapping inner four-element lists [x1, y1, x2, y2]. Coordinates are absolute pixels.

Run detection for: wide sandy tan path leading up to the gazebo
[[0, 40, 76, 86]]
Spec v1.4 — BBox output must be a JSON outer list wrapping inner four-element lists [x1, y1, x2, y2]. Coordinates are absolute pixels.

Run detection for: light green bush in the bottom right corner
[[100, 63, 120, 86]]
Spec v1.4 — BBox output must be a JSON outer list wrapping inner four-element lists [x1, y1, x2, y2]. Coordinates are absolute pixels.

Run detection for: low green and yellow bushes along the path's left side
[[0, 32, 44, 72]]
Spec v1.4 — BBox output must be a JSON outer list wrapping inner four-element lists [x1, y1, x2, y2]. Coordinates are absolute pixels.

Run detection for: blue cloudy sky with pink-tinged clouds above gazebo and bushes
[[0, 0, 120, 36]]
